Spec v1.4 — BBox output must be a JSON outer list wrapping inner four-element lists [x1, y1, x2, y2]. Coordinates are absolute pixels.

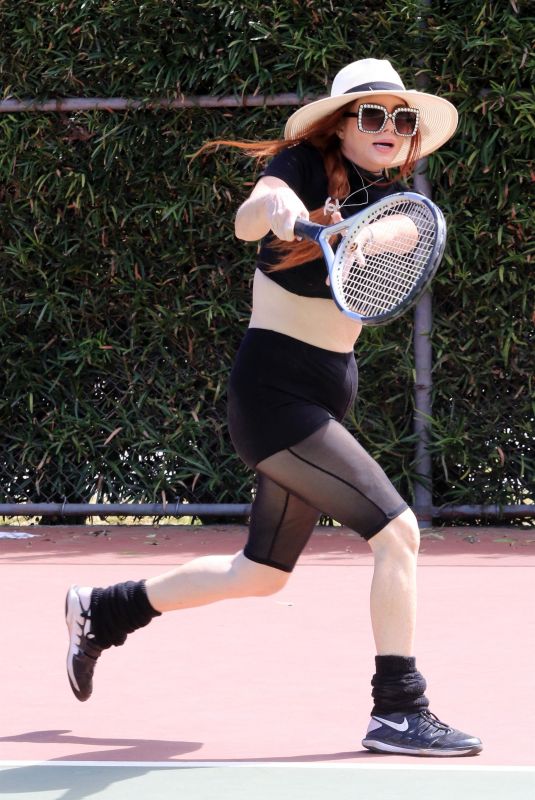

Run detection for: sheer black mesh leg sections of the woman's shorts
[[245, 420, 407, 571]]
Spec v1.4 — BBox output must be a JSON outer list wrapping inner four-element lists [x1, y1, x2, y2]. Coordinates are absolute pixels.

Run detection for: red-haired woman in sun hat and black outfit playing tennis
[[66, 59, 481, 756]]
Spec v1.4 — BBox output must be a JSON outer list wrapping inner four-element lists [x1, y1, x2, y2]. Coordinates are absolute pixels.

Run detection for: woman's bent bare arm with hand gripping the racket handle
[[234, 175, 308, 242]]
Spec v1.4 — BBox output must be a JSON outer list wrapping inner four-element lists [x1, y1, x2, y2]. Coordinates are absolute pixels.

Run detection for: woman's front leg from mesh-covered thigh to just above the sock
[[258, 420, 419, 656]]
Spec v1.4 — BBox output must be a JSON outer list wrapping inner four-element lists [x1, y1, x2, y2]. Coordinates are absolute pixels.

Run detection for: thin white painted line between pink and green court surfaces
[[0, 761, 535, 773]]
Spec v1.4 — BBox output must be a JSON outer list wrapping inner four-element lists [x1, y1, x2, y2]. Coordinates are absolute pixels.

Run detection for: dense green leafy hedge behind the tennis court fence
[[0, 0, 535, 520]]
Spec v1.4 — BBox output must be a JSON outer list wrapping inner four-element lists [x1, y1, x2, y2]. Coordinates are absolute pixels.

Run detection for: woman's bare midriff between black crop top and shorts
[[249, 269, 362, 353]]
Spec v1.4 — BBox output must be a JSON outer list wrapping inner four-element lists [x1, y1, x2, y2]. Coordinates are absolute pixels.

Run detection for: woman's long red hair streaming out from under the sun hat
[[195, 101, 421, 272]]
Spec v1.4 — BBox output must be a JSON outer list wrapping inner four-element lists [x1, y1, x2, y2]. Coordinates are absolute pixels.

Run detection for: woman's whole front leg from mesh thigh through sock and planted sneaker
[[258, 421, 481, 756]]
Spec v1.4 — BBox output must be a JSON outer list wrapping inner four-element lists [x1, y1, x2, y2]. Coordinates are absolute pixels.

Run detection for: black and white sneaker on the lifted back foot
[[65, 586, 102, 702]]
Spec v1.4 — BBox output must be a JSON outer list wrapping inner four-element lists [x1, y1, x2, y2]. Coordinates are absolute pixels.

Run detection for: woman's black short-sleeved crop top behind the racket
[[256, 142, 407, 298]]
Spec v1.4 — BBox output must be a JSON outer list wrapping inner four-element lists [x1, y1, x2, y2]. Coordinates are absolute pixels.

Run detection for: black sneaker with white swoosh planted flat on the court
[[362, 709, 483, 756]]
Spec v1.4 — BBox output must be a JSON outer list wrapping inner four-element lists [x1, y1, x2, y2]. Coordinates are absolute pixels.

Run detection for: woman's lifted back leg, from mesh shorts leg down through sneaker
[[66, 475, 318, 701]]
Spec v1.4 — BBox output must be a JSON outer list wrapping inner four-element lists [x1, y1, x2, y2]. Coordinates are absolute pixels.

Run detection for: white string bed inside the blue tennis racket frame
[[335, 201, 436, 317]]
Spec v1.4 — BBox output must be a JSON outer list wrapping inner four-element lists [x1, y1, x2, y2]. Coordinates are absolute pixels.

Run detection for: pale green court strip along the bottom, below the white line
[[0, 761, 535, 800]]
